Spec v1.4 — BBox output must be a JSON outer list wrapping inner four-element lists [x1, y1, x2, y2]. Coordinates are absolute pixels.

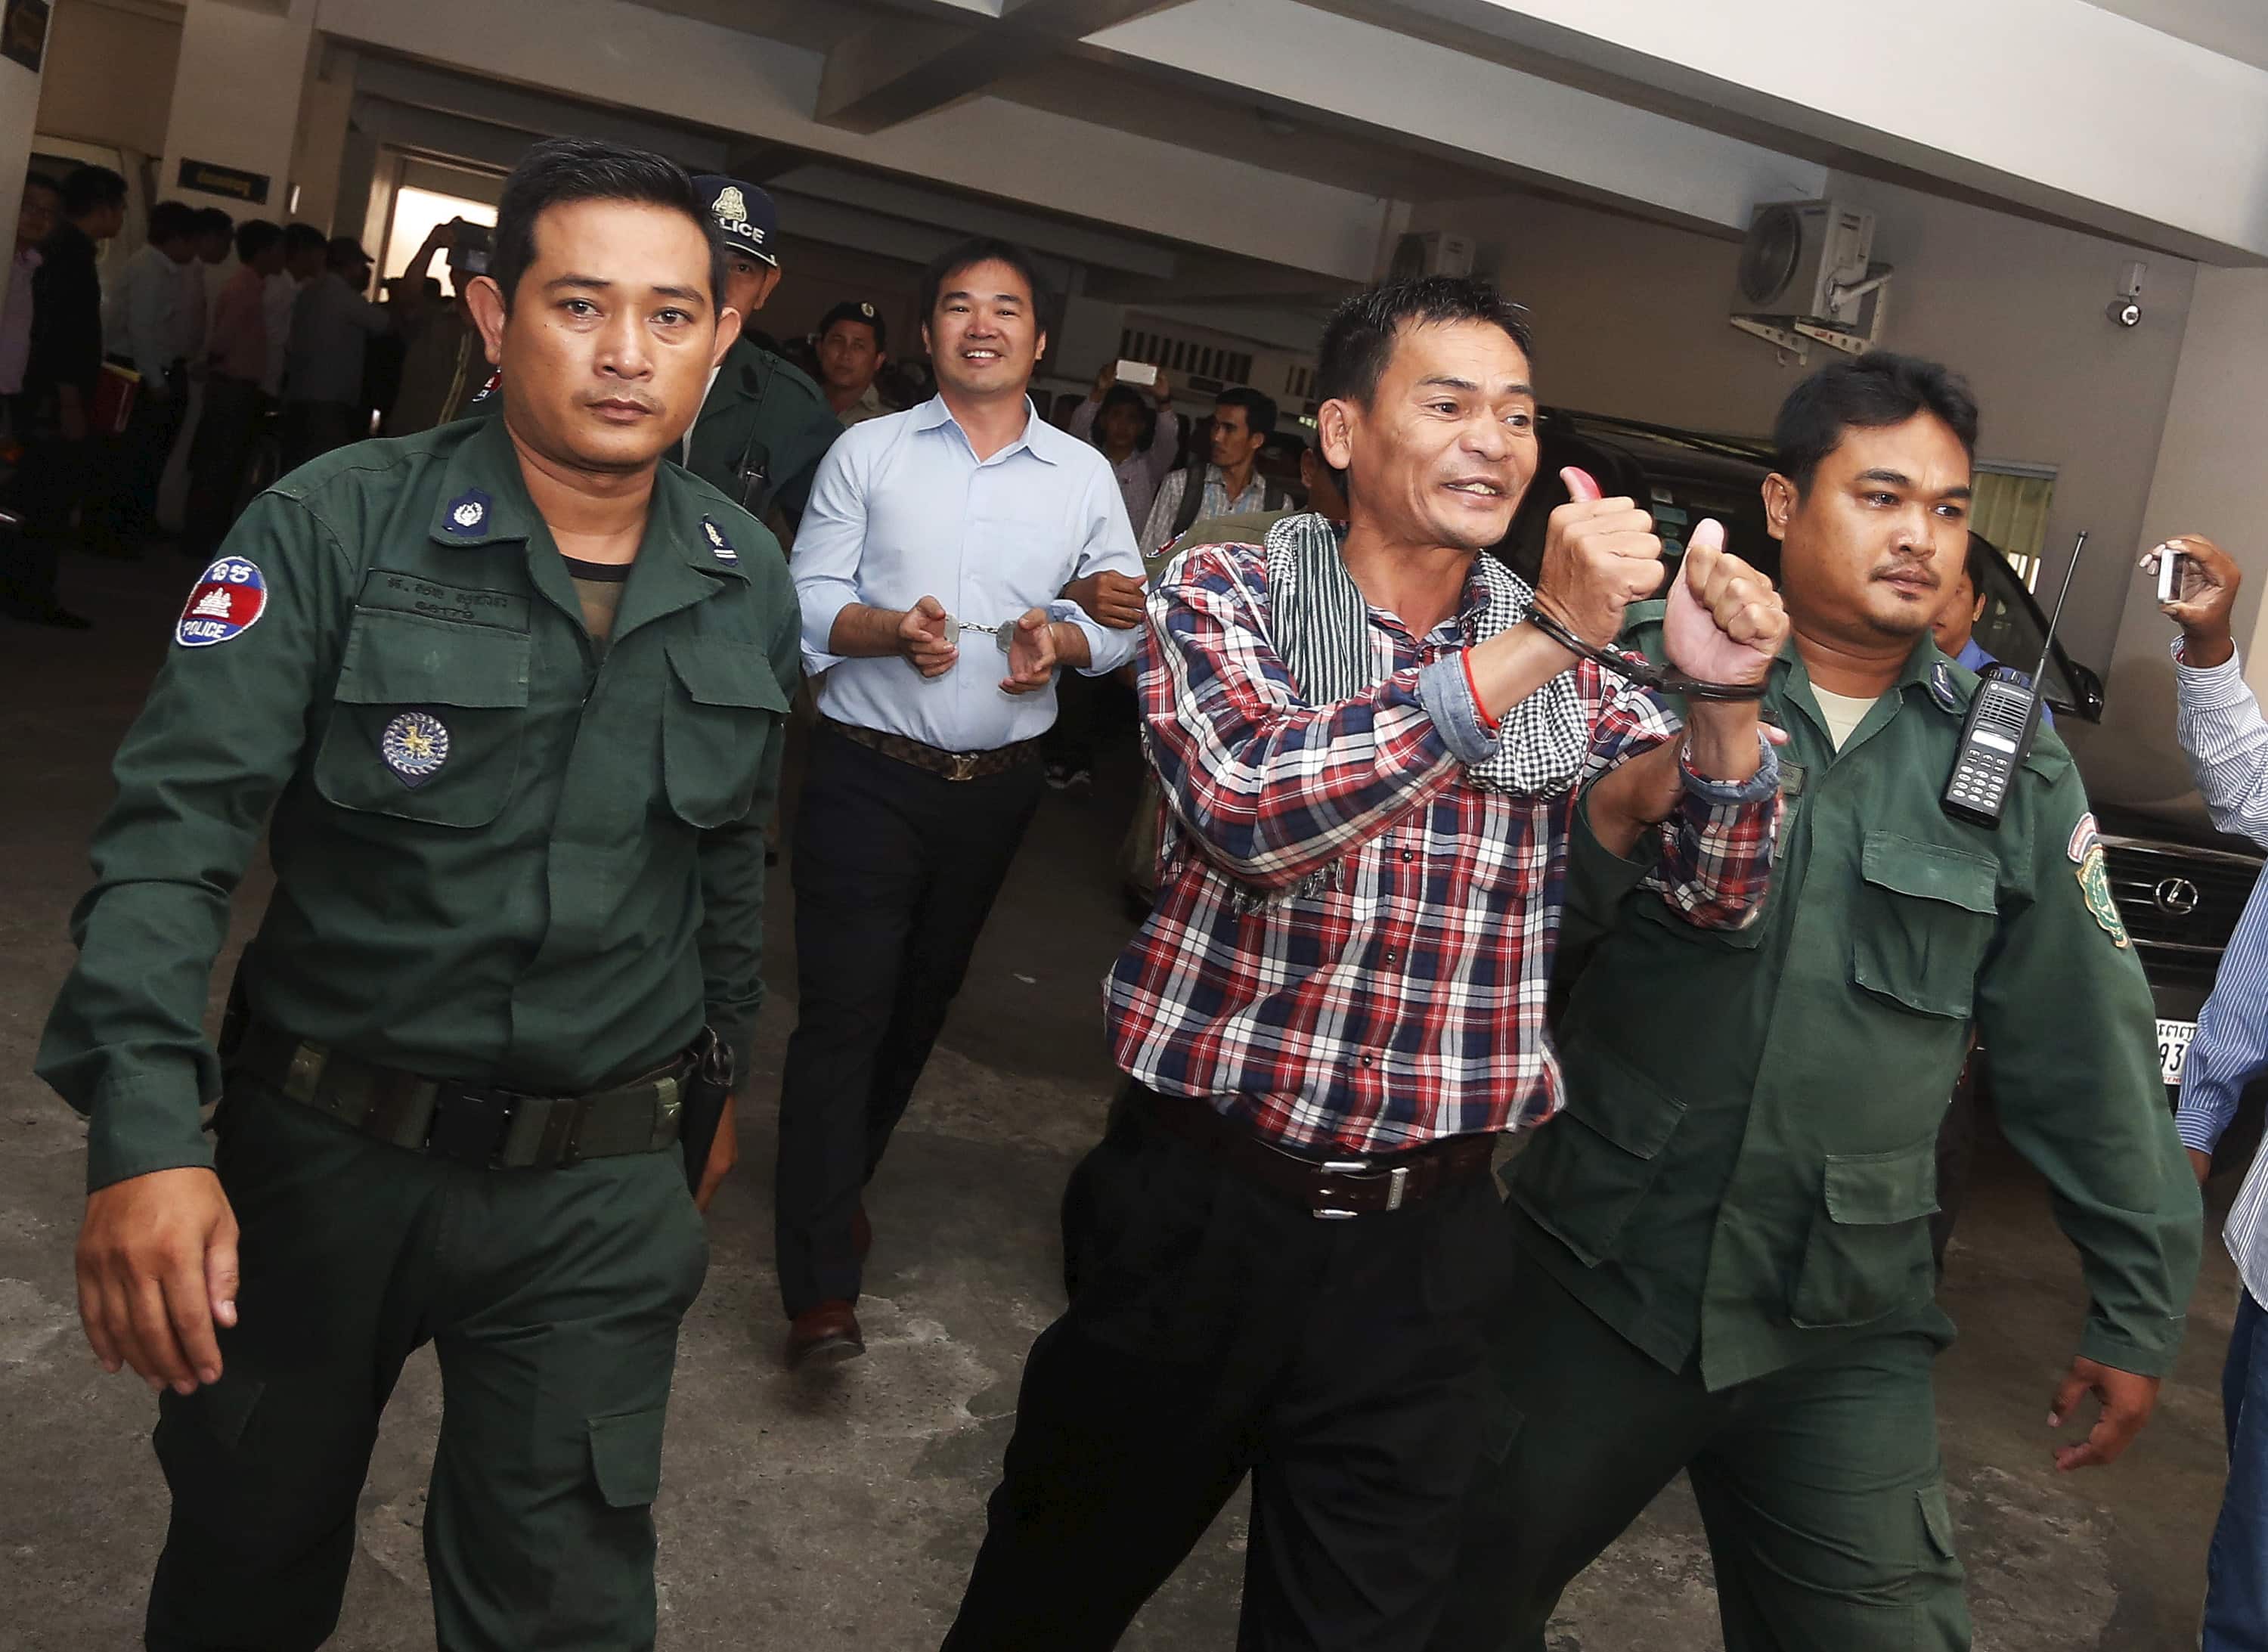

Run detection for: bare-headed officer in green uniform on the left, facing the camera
[[39, 138, 796, 1652]]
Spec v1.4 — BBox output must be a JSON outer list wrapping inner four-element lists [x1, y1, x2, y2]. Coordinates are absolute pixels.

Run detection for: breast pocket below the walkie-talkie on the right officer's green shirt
[[1851, 833, 1998, 1021]]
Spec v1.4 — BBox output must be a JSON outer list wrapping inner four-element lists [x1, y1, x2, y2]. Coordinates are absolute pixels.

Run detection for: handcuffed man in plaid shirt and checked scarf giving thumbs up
[[946, 277, 1787, 1652]]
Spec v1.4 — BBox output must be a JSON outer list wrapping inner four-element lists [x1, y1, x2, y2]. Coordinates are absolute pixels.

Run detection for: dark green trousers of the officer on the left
[[147, 1078, 708, 1652]]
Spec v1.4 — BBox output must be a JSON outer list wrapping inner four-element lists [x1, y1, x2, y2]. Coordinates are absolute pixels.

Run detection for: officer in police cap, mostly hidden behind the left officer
[[680, 175, 844, 535]]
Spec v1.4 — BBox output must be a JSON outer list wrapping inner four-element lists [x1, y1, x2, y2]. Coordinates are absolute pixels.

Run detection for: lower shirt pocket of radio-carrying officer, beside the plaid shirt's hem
[[1513, 1055, 1685, 1269]]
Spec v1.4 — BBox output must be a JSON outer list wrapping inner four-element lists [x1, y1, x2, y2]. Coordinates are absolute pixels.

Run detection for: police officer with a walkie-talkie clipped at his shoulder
[[1433, 354, 2200, 1652]]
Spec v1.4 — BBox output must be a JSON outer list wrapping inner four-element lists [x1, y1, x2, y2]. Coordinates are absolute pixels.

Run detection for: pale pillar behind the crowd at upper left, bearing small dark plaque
[[156, 0, 315, 222]]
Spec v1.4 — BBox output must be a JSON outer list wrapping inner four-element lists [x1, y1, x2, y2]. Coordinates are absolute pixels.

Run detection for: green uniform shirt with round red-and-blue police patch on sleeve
[[39, 420, 798, 1187]]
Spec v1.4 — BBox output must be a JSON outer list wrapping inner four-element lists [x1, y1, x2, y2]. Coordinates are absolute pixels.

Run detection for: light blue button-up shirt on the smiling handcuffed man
[[792, 397, 1141, 751]]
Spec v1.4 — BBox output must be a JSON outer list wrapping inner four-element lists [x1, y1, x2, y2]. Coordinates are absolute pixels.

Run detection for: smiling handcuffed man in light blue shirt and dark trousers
[[776, 240, 1141, 1366]]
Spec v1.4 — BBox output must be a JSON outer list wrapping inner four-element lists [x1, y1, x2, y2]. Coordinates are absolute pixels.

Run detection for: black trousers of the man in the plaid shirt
[[946, 1087, 1510, 1652]]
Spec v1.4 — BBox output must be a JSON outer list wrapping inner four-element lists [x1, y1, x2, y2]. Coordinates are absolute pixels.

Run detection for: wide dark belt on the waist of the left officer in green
[[227, 1021, 696, 1171]]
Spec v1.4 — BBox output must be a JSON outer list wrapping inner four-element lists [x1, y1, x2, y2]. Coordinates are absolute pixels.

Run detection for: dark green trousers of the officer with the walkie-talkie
[[1431, 1257, 1969, 1652]]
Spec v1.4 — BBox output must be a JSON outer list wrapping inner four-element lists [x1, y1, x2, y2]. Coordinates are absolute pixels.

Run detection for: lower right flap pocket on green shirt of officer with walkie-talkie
[[1787, 1137, 1937, 1330]]
